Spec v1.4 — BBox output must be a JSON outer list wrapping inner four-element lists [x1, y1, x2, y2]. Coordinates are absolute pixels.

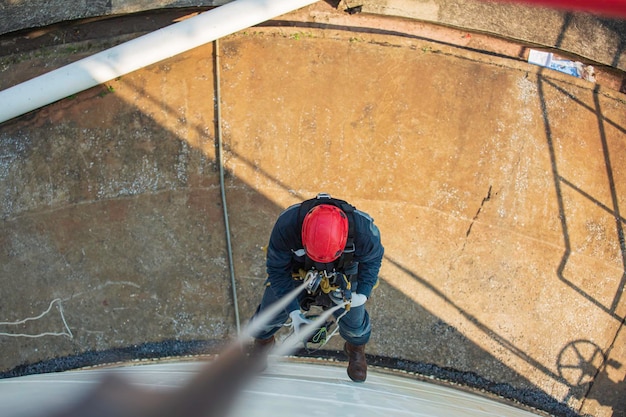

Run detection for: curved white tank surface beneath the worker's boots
[[0, 361, 538, 417]]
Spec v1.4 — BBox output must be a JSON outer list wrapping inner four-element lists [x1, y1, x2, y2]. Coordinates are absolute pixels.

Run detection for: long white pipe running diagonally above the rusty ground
[[0, 0, 317, 123]]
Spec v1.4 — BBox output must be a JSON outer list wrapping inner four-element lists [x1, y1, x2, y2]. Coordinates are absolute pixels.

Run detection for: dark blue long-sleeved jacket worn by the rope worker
[[266, 204, 384, 311]]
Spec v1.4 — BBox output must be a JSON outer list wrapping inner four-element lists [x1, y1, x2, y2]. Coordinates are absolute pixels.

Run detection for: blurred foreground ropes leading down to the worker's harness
[[48, 283, 322, 417]]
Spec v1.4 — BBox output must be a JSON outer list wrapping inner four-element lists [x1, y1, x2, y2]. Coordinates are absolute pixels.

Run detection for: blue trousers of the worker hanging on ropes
[[252, 282, 372, 346]]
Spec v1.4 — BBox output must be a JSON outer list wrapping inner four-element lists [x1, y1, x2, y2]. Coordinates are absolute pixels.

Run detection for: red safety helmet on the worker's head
[[302, 204, 348, 263]]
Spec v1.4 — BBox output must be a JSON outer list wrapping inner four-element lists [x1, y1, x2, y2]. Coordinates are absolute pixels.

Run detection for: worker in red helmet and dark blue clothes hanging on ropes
[[252, 194, 384, 382]]
